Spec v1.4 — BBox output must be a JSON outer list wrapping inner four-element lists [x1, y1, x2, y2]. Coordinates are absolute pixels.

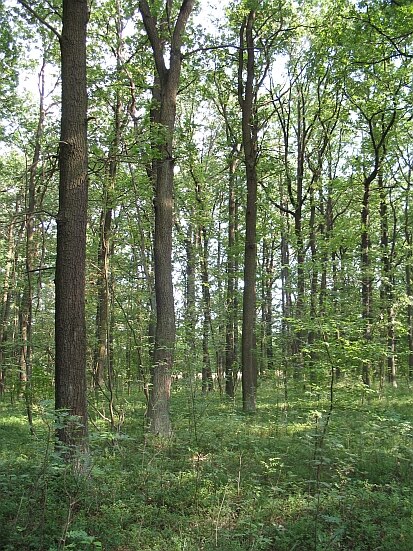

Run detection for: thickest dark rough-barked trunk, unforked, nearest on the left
[[55, 0, 89, 450]]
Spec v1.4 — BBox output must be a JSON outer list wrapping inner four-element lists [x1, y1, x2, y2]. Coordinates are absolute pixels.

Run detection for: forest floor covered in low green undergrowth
[[0, 376, 413, 551]]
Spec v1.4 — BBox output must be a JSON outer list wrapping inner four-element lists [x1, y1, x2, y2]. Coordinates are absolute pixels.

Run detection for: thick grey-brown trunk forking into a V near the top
[[139, 0, 195, 436]]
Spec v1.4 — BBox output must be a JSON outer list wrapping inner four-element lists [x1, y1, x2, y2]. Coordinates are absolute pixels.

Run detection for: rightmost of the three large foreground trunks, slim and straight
[[238, 10, 257, 413]]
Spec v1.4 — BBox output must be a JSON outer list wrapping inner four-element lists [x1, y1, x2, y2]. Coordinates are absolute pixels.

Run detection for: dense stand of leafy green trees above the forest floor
[[0, 0, 413, 443]]
